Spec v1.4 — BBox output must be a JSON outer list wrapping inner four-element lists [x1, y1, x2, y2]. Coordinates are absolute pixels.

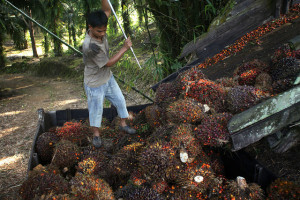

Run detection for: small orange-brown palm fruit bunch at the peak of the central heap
[[176, 67, 205, 88]]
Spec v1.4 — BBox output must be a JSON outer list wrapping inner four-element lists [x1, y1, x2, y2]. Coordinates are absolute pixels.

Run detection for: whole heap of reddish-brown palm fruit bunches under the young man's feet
[[20, 43, 300, 200]]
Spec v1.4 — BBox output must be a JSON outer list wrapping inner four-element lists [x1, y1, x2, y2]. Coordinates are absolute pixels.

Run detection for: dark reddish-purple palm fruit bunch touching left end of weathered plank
[[195, 113, 232, 147]]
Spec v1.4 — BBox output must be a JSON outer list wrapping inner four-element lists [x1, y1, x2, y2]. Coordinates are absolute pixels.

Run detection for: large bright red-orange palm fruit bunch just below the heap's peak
[[185, 79, 225, 112]]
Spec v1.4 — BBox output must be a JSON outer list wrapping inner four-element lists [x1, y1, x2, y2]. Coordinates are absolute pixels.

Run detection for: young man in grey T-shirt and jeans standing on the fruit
[[82, 0, 136, 148]]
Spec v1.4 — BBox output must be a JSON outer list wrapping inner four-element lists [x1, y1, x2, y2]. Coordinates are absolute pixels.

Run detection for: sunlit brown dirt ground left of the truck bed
[[0, 74, 87, 199]]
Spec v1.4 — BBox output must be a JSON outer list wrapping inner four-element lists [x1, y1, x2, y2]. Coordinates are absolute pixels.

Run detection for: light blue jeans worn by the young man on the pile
[[84, 76, 128, 127]]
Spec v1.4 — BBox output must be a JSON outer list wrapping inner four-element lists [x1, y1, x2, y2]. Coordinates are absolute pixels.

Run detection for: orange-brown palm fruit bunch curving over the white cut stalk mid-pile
[[171, 124, 202, 162]]
